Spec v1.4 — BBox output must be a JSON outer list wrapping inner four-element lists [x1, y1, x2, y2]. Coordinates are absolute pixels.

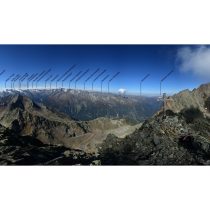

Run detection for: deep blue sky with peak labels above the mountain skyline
[[0, 45, 210, 95]]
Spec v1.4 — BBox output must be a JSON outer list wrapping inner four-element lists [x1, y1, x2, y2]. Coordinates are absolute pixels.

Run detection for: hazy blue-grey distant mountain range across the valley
[[0, 89, 161, 122]]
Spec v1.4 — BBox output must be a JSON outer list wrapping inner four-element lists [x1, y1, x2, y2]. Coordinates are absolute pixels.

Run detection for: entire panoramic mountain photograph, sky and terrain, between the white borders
[[0, 45, 210, 165]]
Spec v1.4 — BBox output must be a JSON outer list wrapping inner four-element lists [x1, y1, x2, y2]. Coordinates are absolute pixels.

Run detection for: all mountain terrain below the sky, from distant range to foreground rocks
[[0, 83, 210, 165]]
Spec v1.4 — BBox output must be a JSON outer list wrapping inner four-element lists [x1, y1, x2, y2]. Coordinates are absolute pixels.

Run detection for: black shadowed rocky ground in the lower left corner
[[0, 126, 95, 165]]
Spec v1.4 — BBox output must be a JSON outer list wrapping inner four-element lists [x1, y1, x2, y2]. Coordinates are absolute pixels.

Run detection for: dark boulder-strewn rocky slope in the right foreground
[[100, 108, 210, 165]]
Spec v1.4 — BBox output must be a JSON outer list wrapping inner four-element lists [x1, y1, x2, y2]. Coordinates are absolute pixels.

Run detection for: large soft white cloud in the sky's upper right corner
[[177, 46, 210, 78]]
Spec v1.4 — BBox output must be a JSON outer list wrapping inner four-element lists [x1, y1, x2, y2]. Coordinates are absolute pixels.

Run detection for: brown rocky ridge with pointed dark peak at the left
[[0, 94, 88, 144]]
